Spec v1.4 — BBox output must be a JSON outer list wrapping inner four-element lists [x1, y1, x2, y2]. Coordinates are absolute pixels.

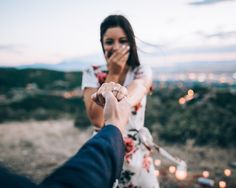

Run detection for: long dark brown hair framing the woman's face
[[100, 15, 140, 69]]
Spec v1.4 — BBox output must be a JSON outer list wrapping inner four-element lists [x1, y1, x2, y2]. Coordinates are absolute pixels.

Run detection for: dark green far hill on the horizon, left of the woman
[[0, 68, 82, 92]]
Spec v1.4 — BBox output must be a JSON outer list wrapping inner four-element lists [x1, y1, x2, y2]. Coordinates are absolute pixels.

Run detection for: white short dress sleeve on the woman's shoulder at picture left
[[81, 67, 99, 90]]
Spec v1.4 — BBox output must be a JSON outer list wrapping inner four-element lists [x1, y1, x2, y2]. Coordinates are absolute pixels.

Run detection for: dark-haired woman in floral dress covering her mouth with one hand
[[82, 15, 159, 188]]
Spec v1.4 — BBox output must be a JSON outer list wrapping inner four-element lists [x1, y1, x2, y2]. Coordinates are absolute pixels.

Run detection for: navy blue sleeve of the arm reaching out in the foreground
[[41, 125, 125, 188]]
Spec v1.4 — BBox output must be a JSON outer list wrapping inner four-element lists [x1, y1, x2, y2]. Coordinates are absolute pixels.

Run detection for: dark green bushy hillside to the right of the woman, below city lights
[[145, 84, 236, 146]]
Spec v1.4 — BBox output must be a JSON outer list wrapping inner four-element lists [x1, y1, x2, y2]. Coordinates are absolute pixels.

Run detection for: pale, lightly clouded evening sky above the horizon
[[0, 0, 236, 66]]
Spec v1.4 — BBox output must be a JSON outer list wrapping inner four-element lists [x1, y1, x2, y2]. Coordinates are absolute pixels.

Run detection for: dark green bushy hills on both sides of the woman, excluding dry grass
[[0, 68, 236, 147]]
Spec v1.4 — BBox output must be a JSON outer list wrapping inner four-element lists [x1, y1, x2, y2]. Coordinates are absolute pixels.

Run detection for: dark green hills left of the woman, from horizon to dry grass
[[0, 68, 89, 125]]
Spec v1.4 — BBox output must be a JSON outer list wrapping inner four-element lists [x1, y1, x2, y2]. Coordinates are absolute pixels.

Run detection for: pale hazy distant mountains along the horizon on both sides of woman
[[2, 57, 236, 73]]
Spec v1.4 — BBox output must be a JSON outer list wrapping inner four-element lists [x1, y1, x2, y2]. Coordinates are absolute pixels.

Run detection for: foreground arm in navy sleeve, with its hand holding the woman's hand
[[0, 86, 130, 188]]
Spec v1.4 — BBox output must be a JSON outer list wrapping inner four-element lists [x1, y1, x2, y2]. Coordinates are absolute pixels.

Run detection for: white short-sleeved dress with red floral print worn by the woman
[[82, 65, 159, 188]]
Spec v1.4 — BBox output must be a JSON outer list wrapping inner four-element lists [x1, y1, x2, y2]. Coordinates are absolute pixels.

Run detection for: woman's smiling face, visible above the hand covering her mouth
[[102, 27, 129, 57]]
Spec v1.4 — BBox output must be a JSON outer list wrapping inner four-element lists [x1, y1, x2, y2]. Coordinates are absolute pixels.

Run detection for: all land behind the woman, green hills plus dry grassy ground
[[0, 68, 236, 188]]
